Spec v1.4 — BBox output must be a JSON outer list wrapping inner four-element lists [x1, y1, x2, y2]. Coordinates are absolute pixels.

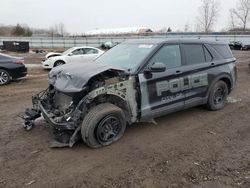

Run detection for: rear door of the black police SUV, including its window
[[181, 44, 215, 107]]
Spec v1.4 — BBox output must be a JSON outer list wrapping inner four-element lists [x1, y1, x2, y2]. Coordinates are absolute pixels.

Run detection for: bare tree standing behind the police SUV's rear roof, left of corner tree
[[197, 0, 220, 33]]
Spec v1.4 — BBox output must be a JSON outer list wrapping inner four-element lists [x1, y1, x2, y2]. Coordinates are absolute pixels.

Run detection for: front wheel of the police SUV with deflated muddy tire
[[81, 103, 126, 148]]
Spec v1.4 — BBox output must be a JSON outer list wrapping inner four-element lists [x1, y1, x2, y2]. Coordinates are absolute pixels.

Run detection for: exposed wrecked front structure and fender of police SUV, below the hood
[[22, 76, 138, 147]]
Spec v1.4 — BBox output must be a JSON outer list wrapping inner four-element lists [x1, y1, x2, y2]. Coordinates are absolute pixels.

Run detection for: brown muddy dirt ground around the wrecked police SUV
[[0, 52, 250, 188]]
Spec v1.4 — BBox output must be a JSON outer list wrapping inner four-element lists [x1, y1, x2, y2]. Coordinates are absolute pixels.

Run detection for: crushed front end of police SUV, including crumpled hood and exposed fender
[[22, 62, 137, 147]]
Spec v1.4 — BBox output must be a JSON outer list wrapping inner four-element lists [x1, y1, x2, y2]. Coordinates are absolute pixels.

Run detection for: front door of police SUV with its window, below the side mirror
[[139, 44, 185, 121]]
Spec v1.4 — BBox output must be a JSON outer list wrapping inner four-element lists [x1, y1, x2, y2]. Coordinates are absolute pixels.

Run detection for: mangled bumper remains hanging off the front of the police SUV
[[20, 90, 81, 147]]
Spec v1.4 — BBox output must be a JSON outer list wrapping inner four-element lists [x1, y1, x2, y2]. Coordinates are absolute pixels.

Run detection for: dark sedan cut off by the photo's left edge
[[0, 53, 27, 86]]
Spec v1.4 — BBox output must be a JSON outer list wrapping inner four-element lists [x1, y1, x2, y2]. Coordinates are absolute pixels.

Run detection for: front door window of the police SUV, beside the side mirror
[[149, 45, 181, 69]]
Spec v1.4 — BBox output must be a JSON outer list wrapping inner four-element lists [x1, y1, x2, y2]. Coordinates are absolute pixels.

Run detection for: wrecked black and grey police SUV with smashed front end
[[23, 39, 236, 148]]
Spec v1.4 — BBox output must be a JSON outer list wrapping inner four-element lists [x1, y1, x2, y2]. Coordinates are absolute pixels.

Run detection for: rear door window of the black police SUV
[[183, 44, 206, 65]]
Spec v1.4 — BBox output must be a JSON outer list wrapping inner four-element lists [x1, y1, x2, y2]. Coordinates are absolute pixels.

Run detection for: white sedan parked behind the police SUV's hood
[[42, 46, 104, 69]]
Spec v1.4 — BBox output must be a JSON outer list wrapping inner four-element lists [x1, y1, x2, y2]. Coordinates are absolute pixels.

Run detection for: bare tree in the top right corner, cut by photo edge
[[231, 0, 250, 31]]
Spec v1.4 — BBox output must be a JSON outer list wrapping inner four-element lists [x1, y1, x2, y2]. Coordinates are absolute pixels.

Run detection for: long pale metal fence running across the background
[[0, 34, 250, 49]]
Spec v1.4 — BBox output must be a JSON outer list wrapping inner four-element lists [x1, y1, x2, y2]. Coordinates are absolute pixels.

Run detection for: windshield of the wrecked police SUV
[[96, 44, 155, 71]]
